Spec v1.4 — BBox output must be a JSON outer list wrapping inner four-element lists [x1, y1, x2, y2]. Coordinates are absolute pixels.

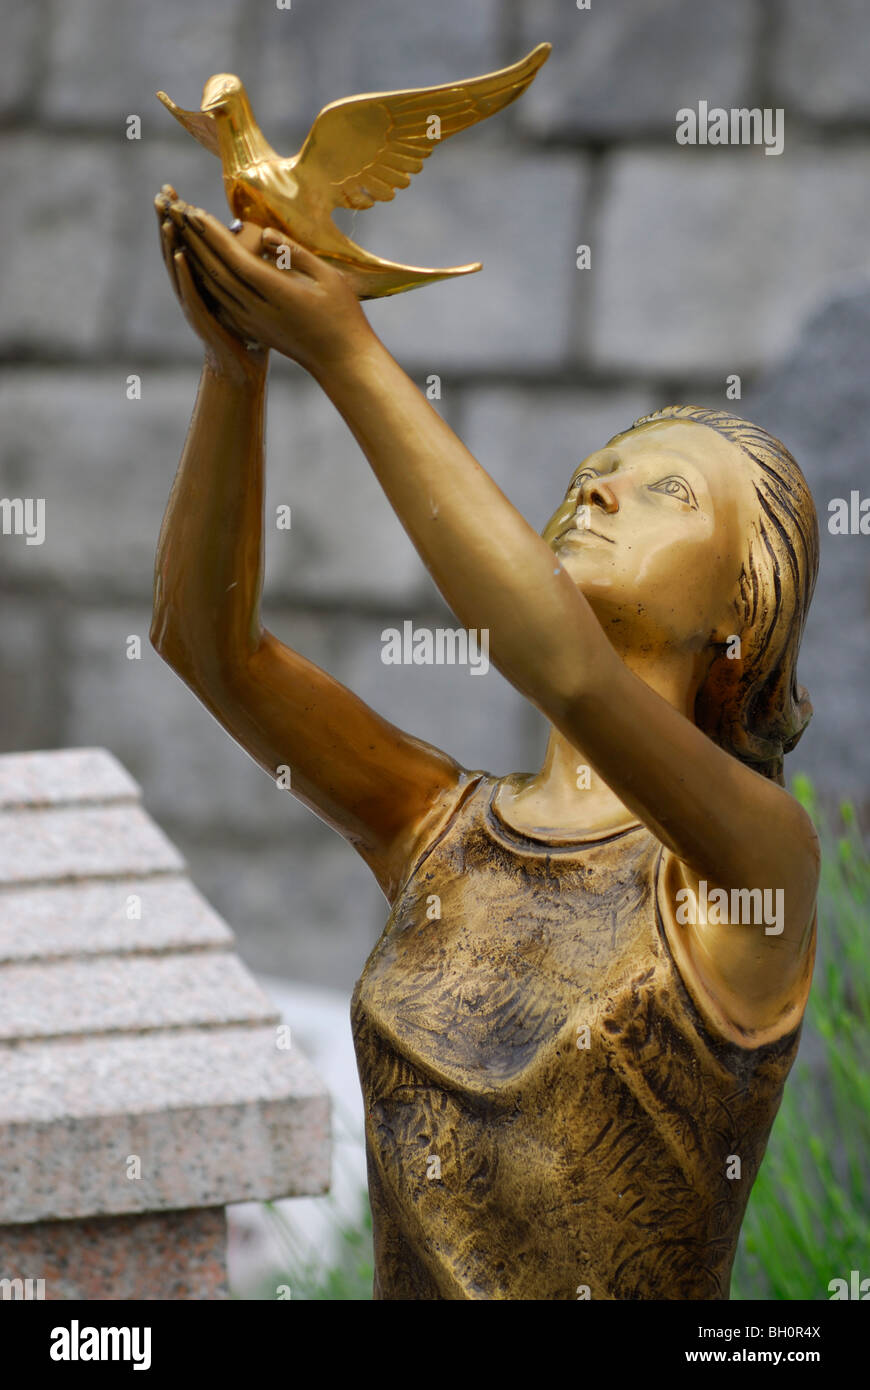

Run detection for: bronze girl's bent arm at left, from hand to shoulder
[[151, 190, 463, 898]]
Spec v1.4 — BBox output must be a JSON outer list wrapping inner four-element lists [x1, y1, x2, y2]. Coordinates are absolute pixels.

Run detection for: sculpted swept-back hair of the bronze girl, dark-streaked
[[608, 406, 819, 784]]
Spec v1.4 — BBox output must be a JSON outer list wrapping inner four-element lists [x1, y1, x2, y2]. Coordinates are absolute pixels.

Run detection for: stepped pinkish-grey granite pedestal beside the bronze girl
[[0, 749, 331, 1300]]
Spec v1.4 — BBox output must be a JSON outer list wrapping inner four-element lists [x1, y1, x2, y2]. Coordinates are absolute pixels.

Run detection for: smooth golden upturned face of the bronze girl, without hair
[[542, 420, 757, 652]]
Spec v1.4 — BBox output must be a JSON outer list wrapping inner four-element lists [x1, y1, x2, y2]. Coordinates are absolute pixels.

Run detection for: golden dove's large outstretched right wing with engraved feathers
[[292, 43, 550, 210]]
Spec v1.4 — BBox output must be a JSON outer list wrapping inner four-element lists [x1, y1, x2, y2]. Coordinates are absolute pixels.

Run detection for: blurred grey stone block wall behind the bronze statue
[[0, 0, 870, 987]]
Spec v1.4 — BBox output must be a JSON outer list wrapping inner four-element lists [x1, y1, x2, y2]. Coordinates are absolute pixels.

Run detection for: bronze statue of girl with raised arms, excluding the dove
[[151, 51, 819, 1300]]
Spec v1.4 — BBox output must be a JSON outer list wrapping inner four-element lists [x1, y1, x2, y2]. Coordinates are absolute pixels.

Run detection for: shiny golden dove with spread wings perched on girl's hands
[[157, 43, 550, 299]]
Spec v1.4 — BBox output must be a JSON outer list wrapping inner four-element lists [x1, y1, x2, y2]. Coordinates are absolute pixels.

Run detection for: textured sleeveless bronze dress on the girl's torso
[[352, 773, 799, 1300]]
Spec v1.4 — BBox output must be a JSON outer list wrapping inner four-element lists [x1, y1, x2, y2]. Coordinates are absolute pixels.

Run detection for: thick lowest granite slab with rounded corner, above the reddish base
[[0, 1027, 329, 1223]]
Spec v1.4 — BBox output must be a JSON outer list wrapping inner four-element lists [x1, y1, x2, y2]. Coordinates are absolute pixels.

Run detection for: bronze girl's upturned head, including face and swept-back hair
[[543, 406, 819, 781]]
